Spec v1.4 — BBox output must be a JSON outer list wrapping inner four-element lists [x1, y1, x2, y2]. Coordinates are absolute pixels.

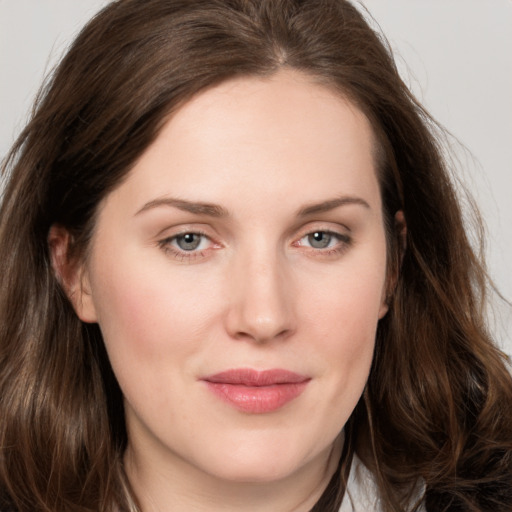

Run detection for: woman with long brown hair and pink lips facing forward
[[0, 0, 512, 512]]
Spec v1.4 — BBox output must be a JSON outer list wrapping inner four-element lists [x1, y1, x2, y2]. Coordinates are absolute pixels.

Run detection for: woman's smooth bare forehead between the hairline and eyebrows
[[105, 71, 379, 218]]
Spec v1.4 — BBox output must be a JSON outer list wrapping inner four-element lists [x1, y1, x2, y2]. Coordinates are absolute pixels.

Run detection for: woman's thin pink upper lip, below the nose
[[202, 368, 310, 387]]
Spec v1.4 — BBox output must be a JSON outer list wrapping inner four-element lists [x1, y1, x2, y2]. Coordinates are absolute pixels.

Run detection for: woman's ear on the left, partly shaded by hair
[[48, 224, 97, 323]]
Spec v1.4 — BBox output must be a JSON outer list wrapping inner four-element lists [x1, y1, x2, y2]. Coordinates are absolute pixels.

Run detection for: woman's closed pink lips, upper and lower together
[[202, 368, 311, 414]]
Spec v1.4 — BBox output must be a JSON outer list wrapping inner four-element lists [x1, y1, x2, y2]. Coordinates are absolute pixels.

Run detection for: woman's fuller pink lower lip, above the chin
[[206, 380, 309, 414]]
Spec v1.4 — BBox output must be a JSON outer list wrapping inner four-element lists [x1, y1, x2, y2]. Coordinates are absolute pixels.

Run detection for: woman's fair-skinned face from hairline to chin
[[75, 71, 387, 488]]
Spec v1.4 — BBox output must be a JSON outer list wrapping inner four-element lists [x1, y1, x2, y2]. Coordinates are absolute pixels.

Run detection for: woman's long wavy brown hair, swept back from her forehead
[[0, 0, 512, 512]]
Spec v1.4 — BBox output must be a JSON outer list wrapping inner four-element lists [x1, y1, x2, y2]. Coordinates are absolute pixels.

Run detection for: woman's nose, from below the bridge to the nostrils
[[226, 251, 296, 343]]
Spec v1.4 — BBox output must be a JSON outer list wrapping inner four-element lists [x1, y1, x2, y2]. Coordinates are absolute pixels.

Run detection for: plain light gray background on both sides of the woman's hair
[[0, 0, 512, 354]]
